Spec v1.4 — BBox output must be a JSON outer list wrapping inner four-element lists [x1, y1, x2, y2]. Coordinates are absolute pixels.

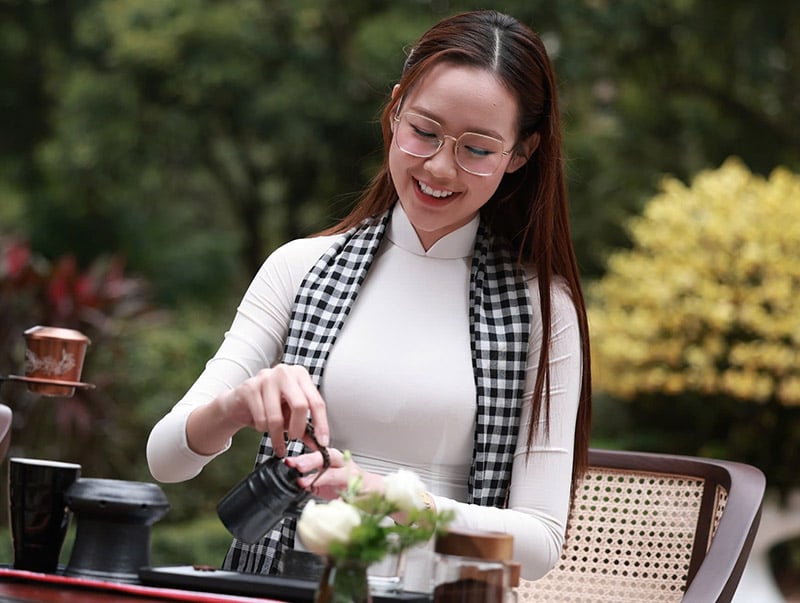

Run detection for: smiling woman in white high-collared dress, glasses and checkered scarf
[[148, 11, 591, 589]]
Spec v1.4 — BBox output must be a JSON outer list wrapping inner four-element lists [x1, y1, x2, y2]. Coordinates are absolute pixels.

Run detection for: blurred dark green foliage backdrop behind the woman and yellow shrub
[[0, 0, 800, 572]]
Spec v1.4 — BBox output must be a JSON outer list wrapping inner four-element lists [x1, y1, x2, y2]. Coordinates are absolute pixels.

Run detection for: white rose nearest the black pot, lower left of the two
[[297, 499, 361, 555]]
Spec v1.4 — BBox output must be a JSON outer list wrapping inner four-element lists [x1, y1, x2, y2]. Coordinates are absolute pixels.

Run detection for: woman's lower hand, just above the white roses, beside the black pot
[[284, 448, 383, 500]]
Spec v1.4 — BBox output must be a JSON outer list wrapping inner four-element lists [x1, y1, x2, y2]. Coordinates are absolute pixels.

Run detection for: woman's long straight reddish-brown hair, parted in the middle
[[327, 11, 592, 487]]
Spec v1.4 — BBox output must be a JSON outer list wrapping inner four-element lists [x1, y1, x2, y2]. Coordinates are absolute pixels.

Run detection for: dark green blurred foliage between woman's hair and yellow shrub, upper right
[[554, 0, 800, 276]]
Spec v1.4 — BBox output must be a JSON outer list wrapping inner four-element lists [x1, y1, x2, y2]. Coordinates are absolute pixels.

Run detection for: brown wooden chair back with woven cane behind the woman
[[519, 449, 766, 603]]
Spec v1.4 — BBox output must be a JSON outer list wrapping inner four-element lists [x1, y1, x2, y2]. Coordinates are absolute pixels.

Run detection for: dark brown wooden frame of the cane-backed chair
[[589, 448, 766, 603]]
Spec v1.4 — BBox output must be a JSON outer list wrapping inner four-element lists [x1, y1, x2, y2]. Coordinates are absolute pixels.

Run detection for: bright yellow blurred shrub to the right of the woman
[[589, 159, 800, 406]]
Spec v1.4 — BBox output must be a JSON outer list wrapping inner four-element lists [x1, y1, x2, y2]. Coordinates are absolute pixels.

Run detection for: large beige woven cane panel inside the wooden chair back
[[519, 468, 708, 603]]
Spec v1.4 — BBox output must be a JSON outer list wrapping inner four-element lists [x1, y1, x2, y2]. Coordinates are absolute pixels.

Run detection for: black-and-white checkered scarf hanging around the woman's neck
[[224, 210, 531, 574]]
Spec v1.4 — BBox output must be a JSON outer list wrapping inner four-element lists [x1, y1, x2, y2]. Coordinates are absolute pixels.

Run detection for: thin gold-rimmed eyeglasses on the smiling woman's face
[[394, 111, 511, 176]]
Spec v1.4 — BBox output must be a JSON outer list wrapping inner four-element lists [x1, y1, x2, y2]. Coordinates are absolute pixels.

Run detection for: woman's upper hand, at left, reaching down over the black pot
[[186, 364, 330, 457]]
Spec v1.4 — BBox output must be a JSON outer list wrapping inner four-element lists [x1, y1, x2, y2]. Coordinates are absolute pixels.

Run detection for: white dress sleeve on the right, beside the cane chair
[[434, 279, 583, 580]]
